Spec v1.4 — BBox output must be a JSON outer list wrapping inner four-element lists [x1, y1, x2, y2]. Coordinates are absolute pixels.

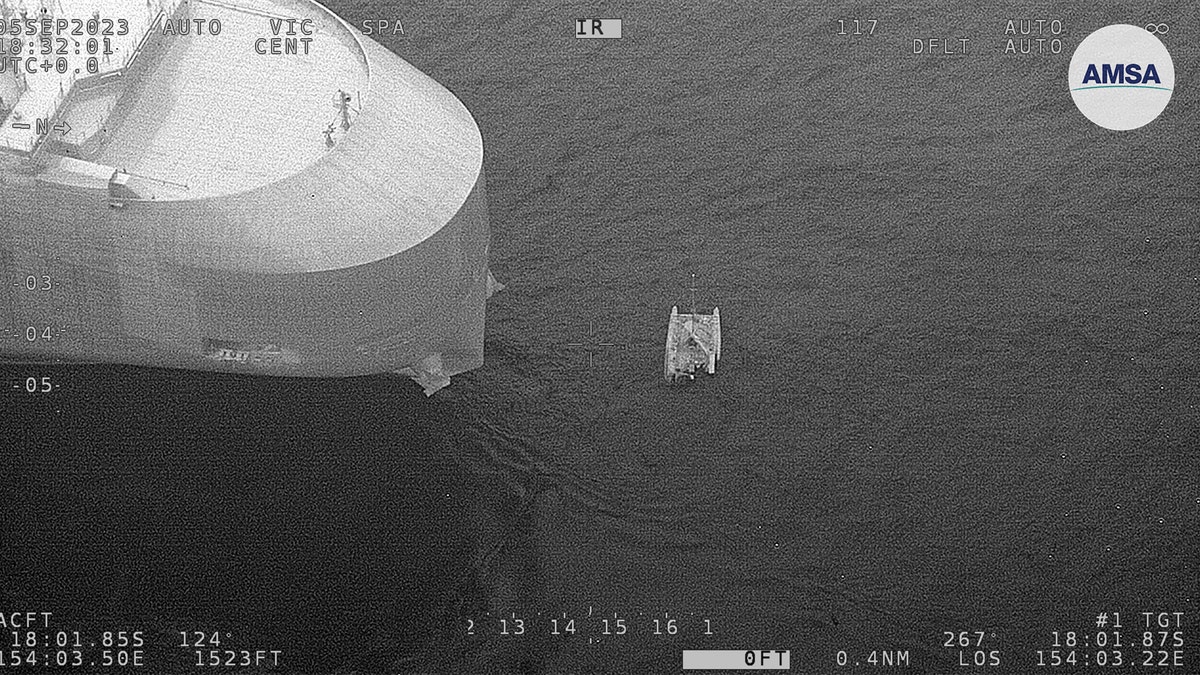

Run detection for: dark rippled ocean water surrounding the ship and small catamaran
[[7, 2, 1200, 673]]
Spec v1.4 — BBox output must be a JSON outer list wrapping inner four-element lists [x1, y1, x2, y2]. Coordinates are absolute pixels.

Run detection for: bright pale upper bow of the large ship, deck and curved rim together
[[0, 0, 486, 274]]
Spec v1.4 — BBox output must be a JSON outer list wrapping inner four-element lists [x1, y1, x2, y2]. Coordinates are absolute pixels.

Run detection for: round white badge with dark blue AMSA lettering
[[1068, 24, 1175, 131]]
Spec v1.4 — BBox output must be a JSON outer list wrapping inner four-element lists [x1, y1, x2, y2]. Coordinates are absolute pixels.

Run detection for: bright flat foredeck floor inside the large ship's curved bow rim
[[96, 0, 368, 199]]
